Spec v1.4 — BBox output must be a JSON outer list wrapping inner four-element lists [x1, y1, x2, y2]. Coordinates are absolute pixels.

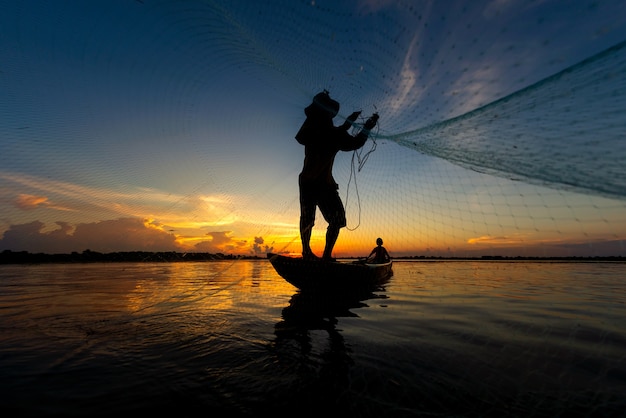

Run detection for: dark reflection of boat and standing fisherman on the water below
[[274, 274, 387, 412]]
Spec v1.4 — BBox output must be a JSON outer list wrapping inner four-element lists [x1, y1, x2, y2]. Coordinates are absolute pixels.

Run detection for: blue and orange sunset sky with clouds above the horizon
[[0, 0, 626, 257]]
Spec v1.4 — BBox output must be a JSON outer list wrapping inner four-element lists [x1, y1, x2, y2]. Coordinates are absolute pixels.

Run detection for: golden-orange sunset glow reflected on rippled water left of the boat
[[0, 260, 295, 349]]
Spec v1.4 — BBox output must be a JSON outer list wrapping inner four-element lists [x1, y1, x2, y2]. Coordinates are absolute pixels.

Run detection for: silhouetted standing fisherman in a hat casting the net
[[296, 91, 378, 261]]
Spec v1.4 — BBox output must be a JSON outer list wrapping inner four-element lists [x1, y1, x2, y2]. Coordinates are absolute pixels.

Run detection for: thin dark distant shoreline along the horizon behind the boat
[[0, 250, 626, 264]]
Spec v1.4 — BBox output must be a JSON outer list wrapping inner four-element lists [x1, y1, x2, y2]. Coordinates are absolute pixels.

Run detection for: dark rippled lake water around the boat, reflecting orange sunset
[[0, 260, 626, 417]]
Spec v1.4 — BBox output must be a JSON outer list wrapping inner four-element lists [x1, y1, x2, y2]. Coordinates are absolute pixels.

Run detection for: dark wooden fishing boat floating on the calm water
[[267, 253, 393, 291]]
